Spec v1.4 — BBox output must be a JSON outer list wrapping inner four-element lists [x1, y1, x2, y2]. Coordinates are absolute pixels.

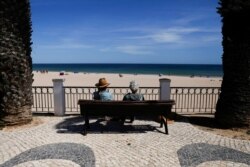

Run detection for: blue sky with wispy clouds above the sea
[[30, 0, 222, 64]]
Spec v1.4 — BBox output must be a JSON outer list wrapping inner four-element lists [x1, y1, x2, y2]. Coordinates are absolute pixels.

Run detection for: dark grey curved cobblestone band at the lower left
[[0, 143, 95, 167]]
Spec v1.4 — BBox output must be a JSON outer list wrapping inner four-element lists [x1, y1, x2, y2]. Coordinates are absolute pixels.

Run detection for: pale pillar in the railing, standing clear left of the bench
[[52, 79, 65, 116]]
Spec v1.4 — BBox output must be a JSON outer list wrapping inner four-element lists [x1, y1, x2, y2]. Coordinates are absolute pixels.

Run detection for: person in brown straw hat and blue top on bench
[[94, 78, 113, 101]]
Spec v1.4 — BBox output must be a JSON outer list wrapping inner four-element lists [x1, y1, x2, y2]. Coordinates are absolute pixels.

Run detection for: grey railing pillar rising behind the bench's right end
[[159, 78, 171, 100]]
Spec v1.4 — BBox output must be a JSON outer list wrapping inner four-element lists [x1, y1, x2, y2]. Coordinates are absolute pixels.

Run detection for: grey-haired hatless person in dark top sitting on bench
[[121, 81, 145, 122]]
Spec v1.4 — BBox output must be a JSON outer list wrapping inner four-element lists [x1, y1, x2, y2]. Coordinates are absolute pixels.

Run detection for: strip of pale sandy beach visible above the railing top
[[33, 71, 222, 87]]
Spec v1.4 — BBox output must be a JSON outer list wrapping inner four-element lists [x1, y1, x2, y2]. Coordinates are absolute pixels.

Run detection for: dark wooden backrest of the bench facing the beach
[[78, 100, 175, 116]]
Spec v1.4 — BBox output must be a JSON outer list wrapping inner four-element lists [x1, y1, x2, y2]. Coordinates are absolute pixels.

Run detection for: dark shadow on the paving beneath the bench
[[55, 116, 164, 134]]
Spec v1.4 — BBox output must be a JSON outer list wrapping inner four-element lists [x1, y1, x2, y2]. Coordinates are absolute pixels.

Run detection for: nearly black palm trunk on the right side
[[215, 0, 250, 127]]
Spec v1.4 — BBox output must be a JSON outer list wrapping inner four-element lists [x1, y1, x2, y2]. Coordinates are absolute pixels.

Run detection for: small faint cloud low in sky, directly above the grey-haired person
[[116, 45, 153, 55]]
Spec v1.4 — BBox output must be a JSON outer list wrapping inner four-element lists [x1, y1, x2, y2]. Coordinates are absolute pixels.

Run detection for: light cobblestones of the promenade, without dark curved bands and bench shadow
[[0, 116, 250, 167]]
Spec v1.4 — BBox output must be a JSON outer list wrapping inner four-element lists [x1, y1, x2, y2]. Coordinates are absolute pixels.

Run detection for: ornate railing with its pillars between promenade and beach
[[32, 80, 220, 115]]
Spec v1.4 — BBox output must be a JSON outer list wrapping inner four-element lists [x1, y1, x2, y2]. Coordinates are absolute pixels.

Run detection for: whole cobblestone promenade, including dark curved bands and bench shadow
[[0, 116, 250, 167]]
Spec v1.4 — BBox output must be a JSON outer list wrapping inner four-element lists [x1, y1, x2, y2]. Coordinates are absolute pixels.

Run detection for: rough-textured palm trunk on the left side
[[0, 0, 33, 125]]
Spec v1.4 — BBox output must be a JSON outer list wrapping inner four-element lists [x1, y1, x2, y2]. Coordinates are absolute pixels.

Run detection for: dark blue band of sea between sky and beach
[[33, 64, 223, 77]]
